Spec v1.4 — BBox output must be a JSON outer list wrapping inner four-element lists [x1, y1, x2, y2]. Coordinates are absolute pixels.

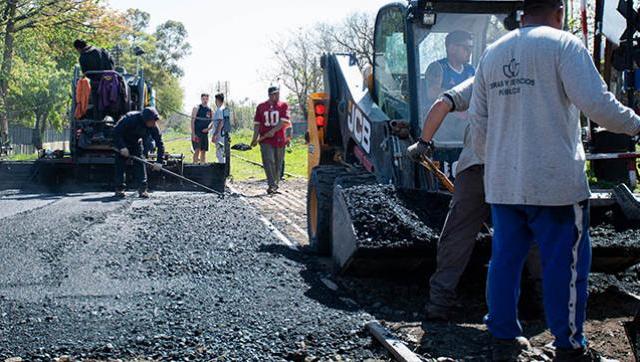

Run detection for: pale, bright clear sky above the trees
[[110, 0, 392, 110]]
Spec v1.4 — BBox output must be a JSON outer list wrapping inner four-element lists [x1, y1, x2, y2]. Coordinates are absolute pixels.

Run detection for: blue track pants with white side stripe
[[485, 201, 591, 349]]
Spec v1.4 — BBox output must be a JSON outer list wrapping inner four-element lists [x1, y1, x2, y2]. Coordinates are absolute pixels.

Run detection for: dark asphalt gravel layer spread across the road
[[0, 193, 388, 361]]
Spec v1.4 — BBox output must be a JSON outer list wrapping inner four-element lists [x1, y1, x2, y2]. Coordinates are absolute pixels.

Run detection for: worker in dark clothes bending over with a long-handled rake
[[113, 108, 164, 199]]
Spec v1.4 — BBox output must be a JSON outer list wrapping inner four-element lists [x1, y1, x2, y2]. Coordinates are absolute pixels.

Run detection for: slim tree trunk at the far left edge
[[0, 1, 18, 146]]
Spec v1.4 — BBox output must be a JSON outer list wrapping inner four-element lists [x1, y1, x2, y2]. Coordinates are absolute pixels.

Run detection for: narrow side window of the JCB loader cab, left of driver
[[374, 7, 409, 119]]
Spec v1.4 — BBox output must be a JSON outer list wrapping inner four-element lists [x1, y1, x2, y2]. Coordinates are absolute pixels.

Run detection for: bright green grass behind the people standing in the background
[[165, 130, 307, 181]]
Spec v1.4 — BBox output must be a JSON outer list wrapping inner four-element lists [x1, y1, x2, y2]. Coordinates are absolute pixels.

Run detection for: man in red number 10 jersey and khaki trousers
[[251, 87, 291, 195]]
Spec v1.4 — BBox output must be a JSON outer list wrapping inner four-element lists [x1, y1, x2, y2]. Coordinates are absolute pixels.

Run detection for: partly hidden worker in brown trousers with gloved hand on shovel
[[407, 77, 541, 321]]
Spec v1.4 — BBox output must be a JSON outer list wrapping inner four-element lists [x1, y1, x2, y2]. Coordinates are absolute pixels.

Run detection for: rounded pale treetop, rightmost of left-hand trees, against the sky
[[154, 20, 191, 77]]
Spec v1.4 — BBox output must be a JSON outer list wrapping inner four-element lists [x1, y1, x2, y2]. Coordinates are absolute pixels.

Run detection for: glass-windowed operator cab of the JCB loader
[[373, 0, 522, 175]]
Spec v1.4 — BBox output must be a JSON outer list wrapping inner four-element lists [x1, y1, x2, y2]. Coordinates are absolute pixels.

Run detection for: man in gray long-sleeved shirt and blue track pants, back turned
[[470, 0, 640, 361]]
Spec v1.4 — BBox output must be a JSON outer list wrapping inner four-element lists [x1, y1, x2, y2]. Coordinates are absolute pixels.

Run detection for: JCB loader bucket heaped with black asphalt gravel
[[332, 184, 640, 276]]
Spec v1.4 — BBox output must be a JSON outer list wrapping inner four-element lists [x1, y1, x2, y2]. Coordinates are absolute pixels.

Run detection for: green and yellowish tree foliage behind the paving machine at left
[[0, 0, 190, 146]]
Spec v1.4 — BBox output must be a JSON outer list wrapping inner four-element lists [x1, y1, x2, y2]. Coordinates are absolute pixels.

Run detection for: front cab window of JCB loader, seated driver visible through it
[[415, 13, 507, 148]]
